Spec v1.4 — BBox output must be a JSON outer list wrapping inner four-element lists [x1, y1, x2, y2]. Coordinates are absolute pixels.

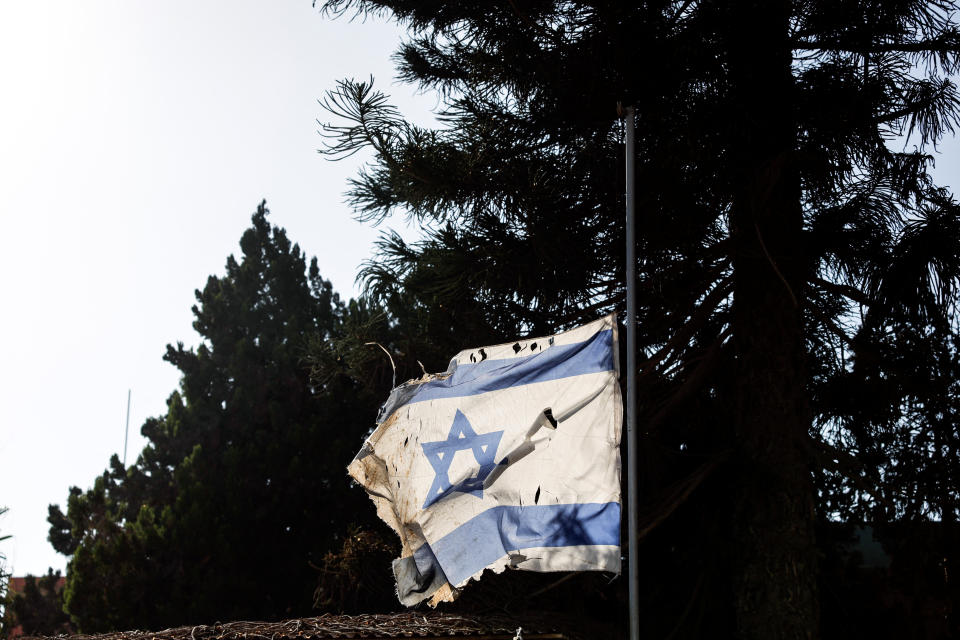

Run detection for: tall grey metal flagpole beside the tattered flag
[[624, 107, 640, 640]]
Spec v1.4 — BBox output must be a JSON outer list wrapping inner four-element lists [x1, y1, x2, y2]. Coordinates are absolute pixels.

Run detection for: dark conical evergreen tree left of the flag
[[49, 205, 376, 632]]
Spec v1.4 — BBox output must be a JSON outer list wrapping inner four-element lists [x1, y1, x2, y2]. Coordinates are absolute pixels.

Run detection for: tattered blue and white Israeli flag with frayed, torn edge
[[348, 314, 623, 606]]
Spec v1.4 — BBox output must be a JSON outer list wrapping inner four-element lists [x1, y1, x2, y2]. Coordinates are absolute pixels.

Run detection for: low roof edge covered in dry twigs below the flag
[[22, 611, 587, 640]]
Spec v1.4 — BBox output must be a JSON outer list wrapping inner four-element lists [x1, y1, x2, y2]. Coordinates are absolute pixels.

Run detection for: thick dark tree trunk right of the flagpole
[[722, 0, 819, 640]]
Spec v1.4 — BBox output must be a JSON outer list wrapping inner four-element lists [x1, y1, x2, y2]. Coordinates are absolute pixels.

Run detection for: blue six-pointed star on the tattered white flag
[[420, 409, 503, 508]]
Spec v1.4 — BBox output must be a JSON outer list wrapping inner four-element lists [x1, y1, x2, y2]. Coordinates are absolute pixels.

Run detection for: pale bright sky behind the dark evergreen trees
[[0, 0, 960, 575]]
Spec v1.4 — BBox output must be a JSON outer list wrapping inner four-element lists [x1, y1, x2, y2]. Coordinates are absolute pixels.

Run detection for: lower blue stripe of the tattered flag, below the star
[[422, 502, 620, 585]]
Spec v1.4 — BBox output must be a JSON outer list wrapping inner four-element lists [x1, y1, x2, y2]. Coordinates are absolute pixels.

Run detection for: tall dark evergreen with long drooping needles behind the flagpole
[[316, 0, 960, 638]]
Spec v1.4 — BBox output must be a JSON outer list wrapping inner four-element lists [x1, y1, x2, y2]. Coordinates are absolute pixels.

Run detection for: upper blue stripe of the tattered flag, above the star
[[403, 329, 613, 404]]
